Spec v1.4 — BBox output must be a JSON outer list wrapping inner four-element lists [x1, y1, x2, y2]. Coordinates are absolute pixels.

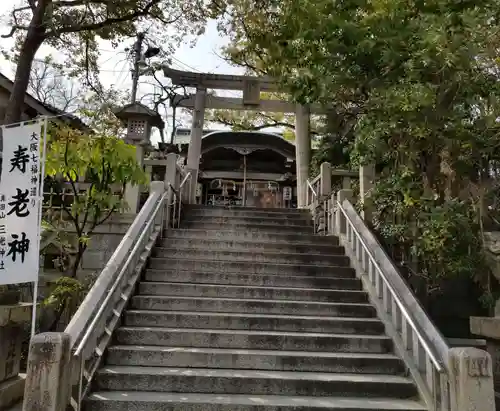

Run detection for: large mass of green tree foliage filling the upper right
[[222, 0, 500, 308]]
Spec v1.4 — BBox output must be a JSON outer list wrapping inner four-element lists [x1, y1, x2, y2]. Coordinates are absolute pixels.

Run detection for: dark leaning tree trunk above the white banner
[[2, 0, 52, 127]]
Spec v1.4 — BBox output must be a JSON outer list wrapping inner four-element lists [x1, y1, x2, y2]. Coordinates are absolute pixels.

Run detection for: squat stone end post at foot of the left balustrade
[[23, 333, 72, 411]]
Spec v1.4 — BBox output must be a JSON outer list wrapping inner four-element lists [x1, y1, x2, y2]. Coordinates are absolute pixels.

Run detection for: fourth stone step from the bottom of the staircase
[[114, 327, 393, 354]]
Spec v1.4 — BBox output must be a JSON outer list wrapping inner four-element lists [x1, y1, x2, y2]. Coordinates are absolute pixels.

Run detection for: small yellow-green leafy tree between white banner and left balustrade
[[45, 120, 147, 277]]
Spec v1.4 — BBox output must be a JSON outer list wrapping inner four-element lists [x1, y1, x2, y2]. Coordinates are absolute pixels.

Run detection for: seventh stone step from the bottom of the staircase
[[138, 281, 368, 303]]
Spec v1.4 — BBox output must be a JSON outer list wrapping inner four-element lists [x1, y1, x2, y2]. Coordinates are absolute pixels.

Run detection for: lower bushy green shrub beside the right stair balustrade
[[370, 173, 488, 294]]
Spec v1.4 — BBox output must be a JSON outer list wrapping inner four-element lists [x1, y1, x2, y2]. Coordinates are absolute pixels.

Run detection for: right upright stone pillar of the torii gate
[[295, 105, 311, 208]]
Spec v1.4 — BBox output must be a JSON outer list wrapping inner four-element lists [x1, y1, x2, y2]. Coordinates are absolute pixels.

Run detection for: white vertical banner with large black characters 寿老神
[[0, 122, 42, 284]]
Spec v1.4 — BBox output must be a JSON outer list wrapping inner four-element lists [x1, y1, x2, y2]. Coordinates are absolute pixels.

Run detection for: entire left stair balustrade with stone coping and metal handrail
[[65, 184, 170, 410]]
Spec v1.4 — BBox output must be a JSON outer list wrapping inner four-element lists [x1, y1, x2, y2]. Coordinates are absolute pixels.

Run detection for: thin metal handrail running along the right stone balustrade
[[337, 201, 449, 372]]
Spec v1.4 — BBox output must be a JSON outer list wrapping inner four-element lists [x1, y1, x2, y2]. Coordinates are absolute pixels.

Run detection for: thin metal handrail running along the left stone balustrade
[[74, 192, 167, 356]]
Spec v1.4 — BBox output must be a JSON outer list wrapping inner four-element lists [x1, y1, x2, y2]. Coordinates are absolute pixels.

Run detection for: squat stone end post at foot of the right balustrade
[[449, 347, 495, 411]]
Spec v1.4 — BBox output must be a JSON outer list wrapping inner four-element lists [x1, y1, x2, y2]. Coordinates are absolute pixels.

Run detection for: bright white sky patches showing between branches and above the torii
[[0, 0, 243, 139]]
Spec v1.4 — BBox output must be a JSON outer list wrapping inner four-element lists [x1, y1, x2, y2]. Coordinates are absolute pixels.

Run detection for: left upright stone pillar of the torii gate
[[187, 88, 207, 203]]
